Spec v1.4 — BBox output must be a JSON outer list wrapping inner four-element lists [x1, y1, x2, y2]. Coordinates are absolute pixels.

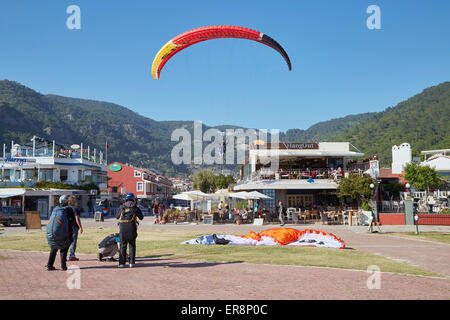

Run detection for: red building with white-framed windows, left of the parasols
[[108, 162, 173, 204]]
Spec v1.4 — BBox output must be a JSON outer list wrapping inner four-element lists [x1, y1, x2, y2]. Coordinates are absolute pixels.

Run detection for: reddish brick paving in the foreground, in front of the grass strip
[[0, 250, 450, 300]]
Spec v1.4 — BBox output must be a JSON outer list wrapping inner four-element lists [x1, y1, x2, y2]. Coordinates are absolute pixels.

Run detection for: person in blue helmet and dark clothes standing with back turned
[[116, 193, 144, 268]]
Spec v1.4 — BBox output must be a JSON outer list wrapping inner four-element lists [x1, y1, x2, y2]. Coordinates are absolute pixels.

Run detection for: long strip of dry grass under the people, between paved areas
[[0, 228, 442, 277]]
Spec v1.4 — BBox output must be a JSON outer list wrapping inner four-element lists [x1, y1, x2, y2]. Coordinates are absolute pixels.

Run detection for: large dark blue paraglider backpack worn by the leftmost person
[[47, 207, 71, 250]]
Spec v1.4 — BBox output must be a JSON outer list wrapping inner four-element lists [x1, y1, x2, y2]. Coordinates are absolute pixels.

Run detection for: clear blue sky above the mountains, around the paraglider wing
[[0, 0, 450, 131]]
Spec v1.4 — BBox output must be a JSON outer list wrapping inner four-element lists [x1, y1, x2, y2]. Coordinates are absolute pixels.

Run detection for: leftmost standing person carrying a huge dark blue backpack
[[45, 195, 75, 271]]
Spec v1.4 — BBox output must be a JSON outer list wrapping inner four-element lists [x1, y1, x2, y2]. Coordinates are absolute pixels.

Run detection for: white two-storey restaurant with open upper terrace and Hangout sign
[[233, 142, 364, 209]]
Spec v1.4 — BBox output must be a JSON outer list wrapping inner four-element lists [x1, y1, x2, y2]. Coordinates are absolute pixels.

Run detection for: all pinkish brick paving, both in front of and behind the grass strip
[[0, 217, 450, 300]]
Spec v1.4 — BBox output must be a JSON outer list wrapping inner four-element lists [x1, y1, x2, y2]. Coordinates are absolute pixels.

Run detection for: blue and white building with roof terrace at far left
[[0, 136, 107, 217]]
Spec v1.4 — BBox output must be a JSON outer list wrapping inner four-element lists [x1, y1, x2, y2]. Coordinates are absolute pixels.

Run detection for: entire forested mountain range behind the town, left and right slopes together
[[0, 80, 450, 176]]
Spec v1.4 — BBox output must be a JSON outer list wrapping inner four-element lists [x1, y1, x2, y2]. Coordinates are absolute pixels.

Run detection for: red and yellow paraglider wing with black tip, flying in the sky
[[152, 26, 291, 79]]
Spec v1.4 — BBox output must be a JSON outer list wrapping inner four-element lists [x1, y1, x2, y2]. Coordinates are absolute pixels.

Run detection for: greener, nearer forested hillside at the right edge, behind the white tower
[[335, 82, 450, 166]]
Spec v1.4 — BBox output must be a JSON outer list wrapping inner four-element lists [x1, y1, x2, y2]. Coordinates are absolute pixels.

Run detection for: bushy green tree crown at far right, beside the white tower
[[404, 163, 445, 192]]
